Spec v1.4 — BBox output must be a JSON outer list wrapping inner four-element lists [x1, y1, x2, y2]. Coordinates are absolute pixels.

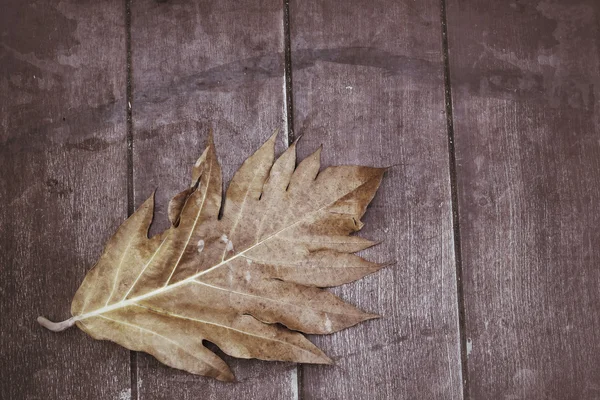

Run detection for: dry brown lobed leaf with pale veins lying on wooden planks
[[38, 130, 384, 381]]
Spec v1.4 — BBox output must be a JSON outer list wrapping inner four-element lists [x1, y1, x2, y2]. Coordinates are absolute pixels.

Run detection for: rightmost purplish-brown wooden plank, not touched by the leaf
[[448, 0, 600, 399]]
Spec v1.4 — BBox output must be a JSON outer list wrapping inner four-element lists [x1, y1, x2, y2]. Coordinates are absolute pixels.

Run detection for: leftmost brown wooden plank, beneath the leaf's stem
[[0, 0, 130, 399]]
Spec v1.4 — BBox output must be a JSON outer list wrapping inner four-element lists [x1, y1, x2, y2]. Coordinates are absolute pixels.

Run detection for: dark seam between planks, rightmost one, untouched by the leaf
[[440, 0, 469, 400]]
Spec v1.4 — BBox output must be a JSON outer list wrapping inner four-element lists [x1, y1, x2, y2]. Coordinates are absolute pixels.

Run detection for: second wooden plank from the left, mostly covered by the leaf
[[132, 0, 297, 400]]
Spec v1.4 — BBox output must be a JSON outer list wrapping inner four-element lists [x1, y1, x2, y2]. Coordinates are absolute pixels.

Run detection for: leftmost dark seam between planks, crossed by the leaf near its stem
[[125, 0, 139, 400]]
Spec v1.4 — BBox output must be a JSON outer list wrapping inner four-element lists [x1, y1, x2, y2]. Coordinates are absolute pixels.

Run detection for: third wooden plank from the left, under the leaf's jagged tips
[[290, 0, 462, 400]]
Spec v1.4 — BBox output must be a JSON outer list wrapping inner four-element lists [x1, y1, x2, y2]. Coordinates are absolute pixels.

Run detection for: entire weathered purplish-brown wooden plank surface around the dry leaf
[[0, 0, 600, 400]]
